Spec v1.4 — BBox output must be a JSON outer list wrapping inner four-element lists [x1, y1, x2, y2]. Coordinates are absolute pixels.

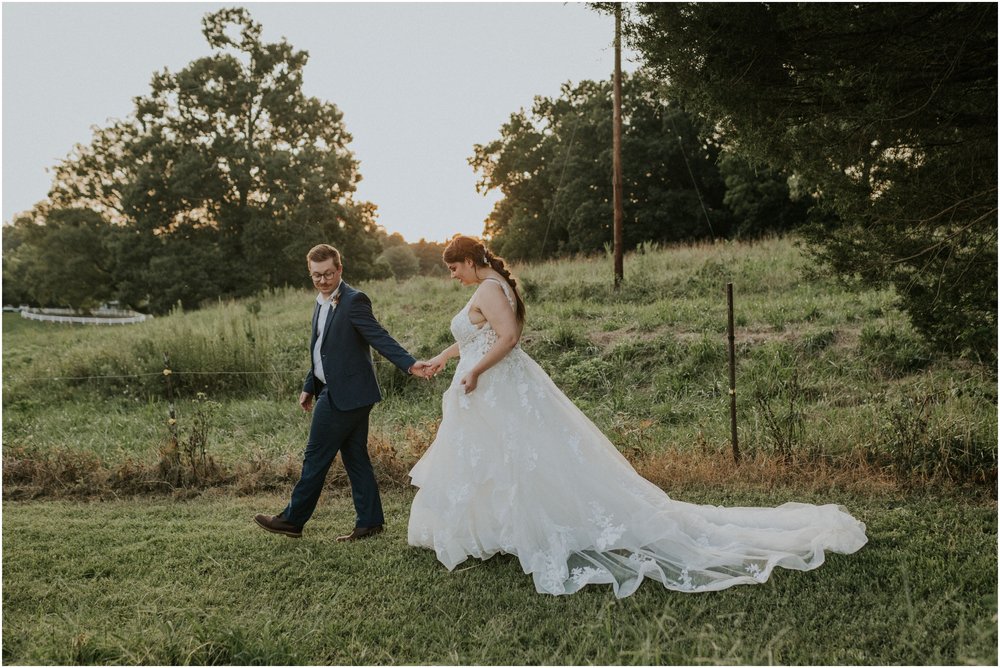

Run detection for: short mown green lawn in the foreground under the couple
[[3, 490, 997, 665]]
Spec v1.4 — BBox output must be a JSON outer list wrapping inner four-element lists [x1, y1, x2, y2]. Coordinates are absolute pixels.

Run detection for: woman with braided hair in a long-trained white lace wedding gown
[[408, 236, 867, 598]]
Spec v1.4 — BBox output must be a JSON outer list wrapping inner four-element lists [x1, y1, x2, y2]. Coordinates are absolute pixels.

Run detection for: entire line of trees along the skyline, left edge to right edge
[[3, 3, 997, 361]]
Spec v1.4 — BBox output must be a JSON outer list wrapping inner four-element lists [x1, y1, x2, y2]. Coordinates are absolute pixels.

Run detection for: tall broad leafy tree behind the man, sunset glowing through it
[[36, 8, 380, 311]]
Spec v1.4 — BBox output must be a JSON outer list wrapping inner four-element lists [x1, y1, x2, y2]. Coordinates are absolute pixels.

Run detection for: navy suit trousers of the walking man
[[280, 387, 385, 527]]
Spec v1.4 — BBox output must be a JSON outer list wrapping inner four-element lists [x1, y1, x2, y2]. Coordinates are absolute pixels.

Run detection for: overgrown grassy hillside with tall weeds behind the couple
[[3, 239, 997, 493]]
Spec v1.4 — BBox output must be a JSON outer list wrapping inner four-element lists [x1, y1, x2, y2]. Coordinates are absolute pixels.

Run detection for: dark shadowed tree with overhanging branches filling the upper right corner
[[632, 3, 997, 360]]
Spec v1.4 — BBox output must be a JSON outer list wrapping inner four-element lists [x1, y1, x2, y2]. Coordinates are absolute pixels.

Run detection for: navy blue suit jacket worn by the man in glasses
[[302, 282, 417, 411]]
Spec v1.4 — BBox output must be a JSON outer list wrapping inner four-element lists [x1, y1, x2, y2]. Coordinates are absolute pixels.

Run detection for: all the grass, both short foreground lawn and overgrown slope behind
[[3, 239, 997, 665]]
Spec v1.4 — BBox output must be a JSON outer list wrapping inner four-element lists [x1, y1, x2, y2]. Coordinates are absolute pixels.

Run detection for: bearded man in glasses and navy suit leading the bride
[[254, 244, 427, 541]]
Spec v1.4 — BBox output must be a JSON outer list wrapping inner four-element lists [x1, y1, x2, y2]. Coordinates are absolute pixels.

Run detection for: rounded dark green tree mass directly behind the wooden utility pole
[[469, 71, 744, 260]]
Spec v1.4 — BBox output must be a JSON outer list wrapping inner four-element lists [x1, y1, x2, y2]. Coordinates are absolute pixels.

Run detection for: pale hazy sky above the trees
[[2, 2, 638, 242]]
